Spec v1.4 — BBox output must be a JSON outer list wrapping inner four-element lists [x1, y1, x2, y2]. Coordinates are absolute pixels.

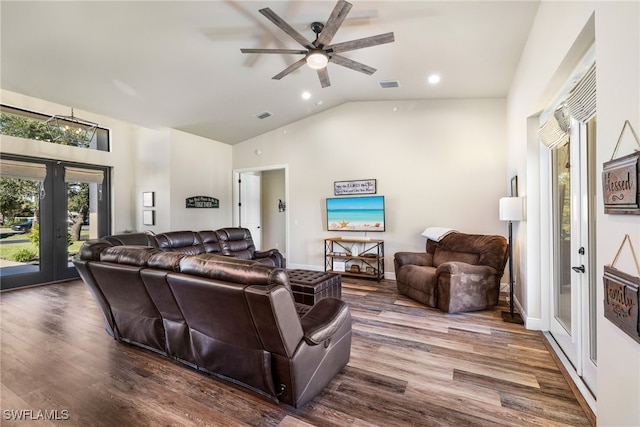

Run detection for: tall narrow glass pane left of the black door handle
[[553, 142, 571, 334]]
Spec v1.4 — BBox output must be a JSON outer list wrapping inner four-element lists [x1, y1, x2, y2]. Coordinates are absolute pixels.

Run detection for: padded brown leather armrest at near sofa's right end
[[300, 298, 350, 345]]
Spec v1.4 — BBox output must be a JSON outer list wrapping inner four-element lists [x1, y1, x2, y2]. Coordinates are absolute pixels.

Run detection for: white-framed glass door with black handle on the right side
[[550, 118, 596, 394]]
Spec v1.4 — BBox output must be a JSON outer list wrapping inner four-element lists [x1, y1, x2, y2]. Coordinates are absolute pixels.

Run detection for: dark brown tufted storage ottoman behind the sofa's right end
[[287, 270, 342, 305]]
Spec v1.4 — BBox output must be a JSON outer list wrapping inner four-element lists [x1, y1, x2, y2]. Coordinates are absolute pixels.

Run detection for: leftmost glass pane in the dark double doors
[[0, 175, 41, 276]]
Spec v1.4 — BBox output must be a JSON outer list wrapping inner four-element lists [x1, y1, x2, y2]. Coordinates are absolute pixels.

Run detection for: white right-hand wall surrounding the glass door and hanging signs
[[508, 1, 640, 426]]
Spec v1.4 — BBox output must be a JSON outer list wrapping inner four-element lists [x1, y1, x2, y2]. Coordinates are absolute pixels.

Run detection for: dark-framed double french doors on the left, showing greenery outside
[[0, 156, 109, 290]]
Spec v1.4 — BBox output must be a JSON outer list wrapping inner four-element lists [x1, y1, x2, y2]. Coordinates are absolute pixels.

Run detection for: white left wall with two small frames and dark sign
[[0, 90, 232, 237]]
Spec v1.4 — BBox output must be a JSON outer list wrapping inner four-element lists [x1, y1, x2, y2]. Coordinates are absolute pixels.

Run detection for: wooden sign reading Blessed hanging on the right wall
[[602, 153, 640, 214]]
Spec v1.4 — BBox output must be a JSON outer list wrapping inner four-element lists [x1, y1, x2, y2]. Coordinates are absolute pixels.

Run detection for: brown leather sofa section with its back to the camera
[[73, 232, 351, 407]]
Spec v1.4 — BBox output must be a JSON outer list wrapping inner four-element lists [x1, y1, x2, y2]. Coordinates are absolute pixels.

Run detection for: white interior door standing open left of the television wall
[[239, 172, 262, 250]]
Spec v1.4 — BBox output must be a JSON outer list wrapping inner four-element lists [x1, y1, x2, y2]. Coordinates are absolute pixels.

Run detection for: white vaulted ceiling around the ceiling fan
[[0, 0, 539, 144]]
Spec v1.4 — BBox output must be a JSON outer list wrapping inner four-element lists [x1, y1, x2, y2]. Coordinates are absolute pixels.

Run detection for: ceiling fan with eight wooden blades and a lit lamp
[[240, 0, 394, 88]]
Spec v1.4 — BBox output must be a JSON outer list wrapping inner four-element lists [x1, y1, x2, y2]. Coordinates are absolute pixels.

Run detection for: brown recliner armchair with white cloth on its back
[[394, 232, 509, 313]]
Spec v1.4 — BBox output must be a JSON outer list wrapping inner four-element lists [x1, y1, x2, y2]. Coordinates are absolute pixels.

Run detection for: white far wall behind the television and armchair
[[233, 99, 508, 277]]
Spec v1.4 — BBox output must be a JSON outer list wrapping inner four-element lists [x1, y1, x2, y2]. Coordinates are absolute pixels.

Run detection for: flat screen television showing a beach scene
[[327, 196, 384, 231]]
